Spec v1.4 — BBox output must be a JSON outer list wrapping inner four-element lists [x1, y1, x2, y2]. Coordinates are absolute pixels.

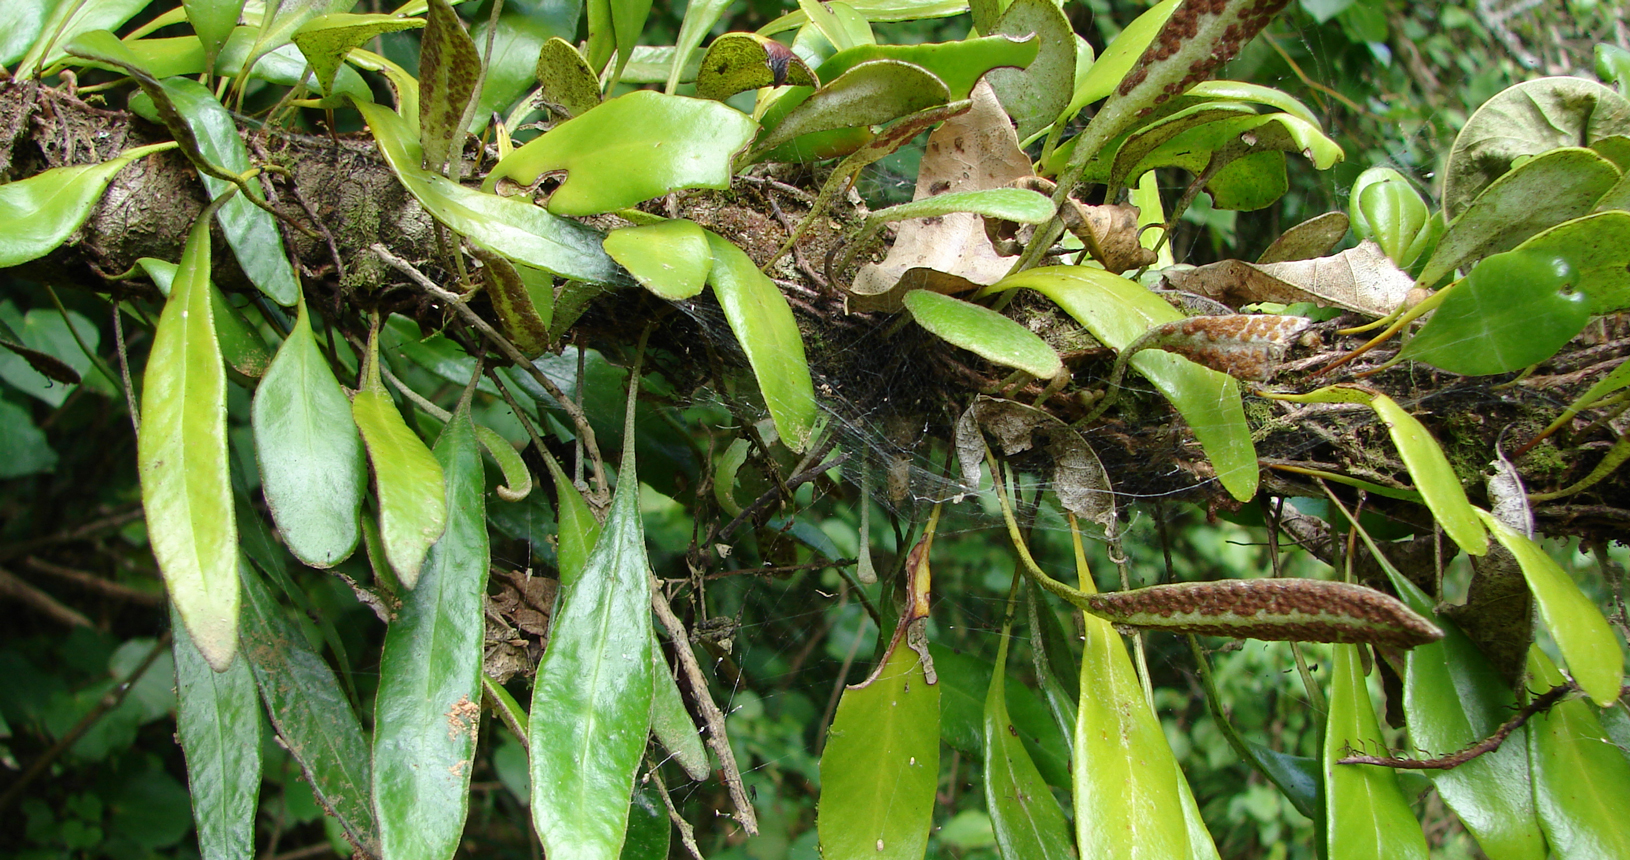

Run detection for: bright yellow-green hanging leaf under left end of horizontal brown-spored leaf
[[1074, 605, 1195, 860]]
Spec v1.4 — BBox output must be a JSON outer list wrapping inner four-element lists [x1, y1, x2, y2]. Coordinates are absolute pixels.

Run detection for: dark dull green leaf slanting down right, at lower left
[[233, 562, 378, 857]]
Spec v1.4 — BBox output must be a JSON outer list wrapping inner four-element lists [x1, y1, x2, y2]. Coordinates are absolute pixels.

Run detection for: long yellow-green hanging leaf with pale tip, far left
[[135, 199, 238, 671]]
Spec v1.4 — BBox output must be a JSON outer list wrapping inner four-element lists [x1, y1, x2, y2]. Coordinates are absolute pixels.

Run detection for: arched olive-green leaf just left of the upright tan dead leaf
[[748, 60, 950, 161]]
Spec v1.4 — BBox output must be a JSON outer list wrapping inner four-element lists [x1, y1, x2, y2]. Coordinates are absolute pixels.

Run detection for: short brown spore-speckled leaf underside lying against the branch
[[1128, 314, 1314, 383]]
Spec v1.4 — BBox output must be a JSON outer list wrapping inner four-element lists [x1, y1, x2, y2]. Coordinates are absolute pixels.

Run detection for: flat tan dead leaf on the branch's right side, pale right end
[[1164, 239, 1418, 316]]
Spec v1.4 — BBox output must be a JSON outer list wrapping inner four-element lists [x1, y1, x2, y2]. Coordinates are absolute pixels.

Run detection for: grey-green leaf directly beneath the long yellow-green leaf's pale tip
[[171, 609, 261, 860]]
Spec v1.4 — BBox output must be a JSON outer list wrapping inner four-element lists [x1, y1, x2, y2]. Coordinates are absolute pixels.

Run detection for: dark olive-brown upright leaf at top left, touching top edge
[[419, 0, 481, 179]]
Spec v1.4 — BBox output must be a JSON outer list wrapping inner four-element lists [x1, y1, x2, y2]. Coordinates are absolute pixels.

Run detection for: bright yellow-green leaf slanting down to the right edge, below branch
[[1477, 510, 1625, 707]]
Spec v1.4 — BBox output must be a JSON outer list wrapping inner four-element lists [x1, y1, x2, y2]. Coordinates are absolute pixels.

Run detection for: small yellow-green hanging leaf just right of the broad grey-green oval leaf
[[350, 322, 447, 590]]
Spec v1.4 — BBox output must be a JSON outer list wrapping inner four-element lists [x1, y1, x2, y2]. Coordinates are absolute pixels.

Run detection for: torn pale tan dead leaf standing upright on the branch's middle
[[849, 81, 1030, 311]]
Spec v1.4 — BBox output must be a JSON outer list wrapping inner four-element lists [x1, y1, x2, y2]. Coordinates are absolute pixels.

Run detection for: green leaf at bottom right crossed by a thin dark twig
[[1324, 645, 1426, 860]]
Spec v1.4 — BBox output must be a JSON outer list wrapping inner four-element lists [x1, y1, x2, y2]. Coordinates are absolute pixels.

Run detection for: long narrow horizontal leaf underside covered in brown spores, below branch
[[1086, 578, 1443, 648]]
